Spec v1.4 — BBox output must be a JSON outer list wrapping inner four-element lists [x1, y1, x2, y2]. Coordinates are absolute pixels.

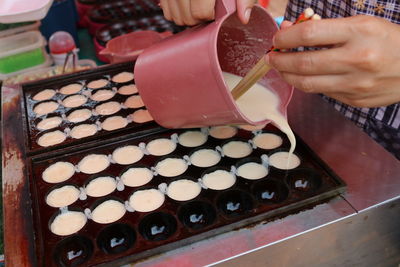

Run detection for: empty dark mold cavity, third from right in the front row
[[217, 190, 254, 217]]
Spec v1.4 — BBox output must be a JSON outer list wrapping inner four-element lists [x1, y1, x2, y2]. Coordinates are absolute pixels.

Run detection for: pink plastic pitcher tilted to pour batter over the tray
[[134, 0, 293, 128]]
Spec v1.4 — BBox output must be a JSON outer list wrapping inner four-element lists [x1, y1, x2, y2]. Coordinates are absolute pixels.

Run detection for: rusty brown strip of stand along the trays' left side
[[2, 87, 35, 266]]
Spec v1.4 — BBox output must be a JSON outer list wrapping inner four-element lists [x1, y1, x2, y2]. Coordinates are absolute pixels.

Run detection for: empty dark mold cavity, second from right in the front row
[[252, 179, 289, 203]]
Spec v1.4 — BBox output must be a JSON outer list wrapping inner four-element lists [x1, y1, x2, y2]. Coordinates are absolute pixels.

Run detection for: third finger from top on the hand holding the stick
[[280, 72, 343, 94]]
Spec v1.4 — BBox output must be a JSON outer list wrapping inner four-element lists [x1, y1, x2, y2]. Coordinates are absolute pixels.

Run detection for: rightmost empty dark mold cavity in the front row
[[286, 169, 322, 193]]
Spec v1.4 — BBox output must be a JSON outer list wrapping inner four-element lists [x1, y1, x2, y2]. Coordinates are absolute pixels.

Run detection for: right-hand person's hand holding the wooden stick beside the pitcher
[[266, 16, 400, 107]]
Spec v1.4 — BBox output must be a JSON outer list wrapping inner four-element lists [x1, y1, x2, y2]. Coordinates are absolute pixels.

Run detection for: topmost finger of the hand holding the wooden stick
[[274, 18, 352, 49]]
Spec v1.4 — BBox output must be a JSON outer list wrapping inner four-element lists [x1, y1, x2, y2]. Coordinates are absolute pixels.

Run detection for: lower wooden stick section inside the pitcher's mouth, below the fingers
[[232, 56, 271, 100]]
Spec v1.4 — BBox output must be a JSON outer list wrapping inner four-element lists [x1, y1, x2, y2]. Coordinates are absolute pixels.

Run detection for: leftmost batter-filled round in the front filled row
[[50, 211, 87, 236]]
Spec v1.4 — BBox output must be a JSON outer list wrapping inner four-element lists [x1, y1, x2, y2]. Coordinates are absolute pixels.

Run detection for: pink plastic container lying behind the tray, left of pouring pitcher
[[100, 31, 172, 63]]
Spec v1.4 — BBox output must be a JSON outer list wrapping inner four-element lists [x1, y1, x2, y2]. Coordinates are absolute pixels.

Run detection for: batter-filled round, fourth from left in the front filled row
[[167, 179, 201, 201]]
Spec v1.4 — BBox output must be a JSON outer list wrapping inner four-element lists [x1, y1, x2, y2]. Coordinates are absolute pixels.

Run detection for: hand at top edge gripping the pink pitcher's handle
[[160, 0, 255, 25]]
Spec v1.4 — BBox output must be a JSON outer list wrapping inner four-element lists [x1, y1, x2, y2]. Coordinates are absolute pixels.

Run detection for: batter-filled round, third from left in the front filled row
[[129, 189, 165, 212]]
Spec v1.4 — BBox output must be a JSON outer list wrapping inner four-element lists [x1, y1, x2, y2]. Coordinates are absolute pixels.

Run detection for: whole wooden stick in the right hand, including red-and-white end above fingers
[[231, 8, 321, 100]]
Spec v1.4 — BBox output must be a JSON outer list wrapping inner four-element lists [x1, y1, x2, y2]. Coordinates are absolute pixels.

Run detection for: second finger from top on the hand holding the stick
[[266, 48, 352, 75]]
